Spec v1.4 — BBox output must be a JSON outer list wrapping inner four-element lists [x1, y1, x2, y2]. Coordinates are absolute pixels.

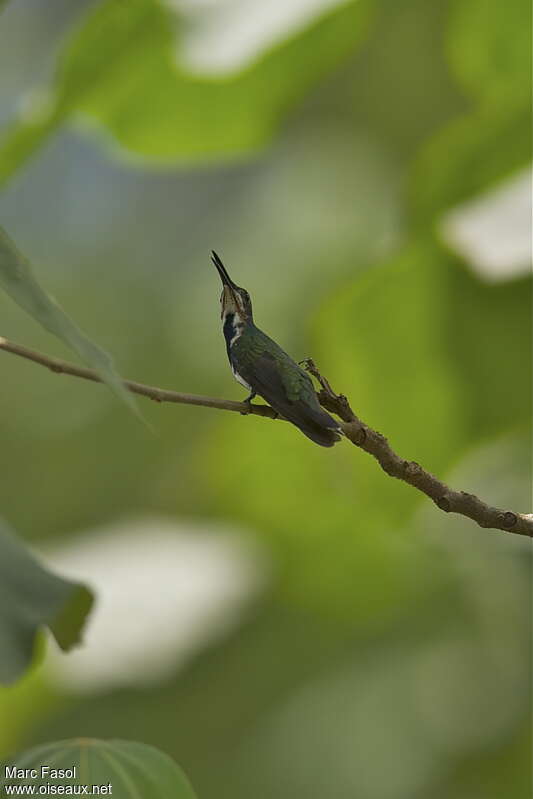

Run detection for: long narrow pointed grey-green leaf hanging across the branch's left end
[[0, 227, 137, 413]]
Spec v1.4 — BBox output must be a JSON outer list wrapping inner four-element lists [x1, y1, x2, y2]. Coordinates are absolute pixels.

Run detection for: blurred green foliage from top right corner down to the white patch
[[410, 0, 532, 223]]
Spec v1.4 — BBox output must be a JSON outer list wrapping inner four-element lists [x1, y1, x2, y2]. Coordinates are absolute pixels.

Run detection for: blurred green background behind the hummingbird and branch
[[0, 0, 531, 799]]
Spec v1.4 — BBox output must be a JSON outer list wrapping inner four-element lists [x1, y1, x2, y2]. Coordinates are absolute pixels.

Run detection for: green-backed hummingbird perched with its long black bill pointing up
[[211, 251, 341, 447]]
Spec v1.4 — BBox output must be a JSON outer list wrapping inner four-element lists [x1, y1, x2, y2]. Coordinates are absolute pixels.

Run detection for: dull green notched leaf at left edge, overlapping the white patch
[[0, 525, 93, 682]]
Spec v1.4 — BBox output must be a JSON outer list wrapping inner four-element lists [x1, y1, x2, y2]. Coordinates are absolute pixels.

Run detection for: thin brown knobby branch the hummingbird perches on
[[0, 336, 533, 537]]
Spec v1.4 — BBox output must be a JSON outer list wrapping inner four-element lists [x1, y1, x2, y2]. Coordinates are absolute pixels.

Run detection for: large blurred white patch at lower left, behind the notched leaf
[[44, 518, 268, 693]]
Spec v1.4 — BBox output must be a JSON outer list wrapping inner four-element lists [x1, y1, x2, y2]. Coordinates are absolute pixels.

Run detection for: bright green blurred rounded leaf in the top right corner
[[448, 0, 531, 107]]
